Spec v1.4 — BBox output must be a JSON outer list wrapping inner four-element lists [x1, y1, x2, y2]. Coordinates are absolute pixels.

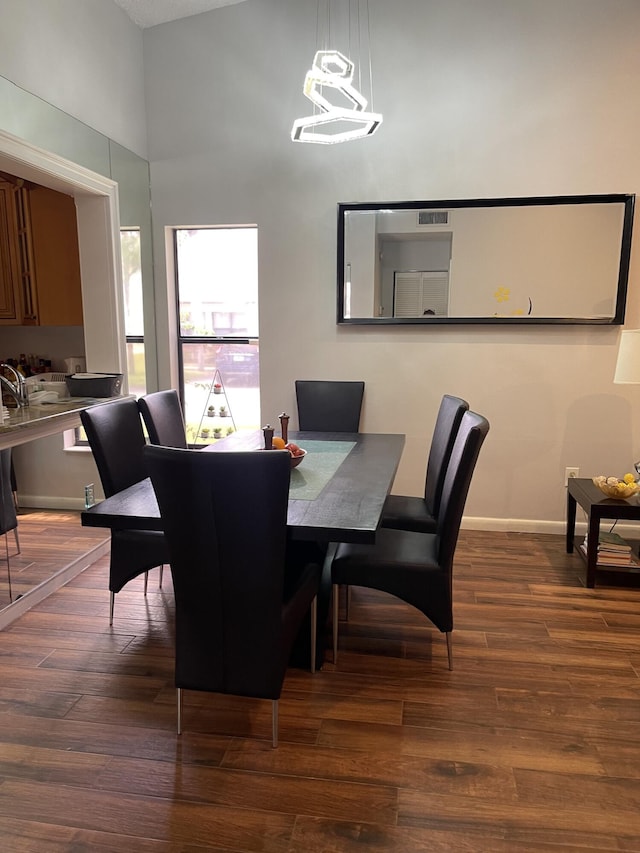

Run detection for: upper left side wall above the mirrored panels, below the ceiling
[[0, 0, 147, 157]]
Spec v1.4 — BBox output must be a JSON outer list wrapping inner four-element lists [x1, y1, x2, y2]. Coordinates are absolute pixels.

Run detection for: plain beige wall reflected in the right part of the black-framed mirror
[[450, 203, 624, 318]]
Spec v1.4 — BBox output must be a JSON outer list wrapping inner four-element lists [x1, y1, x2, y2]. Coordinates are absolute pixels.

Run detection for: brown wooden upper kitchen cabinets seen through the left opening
[[0, 181, 83, 326]]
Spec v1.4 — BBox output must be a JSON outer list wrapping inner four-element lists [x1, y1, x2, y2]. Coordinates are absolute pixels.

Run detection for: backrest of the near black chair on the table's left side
[[80, 397, 149, 498]]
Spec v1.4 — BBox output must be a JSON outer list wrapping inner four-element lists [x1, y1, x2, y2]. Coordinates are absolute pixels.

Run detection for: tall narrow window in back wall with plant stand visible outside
[[174, 226, 260, 444]]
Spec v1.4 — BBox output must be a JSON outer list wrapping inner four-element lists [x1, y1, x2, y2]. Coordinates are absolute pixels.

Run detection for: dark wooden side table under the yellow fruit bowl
[[567, 477, 640, 587]]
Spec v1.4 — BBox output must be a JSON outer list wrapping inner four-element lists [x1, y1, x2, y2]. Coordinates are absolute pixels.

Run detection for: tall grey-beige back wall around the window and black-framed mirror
[[144, 0, 640, 530]]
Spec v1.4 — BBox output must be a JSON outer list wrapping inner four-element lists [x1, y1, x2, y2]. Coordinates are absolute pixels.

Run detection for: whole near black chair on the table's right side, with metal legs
[[331, 412, 489, 669]]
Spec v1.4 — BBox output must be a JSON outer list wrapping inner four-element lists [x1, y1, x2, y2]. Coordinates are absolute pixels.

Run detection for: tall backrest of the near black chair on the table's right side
[[437, 412, 489, 573]]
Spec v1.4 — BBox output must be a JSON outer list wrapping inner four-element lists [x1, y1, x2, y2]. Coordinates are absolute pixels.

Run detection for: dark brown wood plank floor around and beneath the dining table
[[0, 516, 640, 853]]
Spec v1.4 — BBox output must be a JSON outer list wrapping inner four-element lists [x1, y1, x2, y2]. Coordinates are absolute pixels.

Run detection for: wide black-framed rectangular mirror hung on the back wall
[[337, 194, 635, 325]]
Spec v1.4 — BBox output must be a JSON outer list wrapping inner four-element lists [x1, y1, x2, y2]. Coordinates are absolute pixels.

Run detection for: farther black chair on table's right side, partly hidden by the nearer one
[[380, 394, 469, 533]]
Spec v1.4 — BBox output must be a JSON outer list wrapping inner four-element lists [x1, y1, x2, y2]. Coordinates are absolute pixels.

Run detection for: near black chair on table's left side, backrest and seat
[[80, 397, 168, 625]]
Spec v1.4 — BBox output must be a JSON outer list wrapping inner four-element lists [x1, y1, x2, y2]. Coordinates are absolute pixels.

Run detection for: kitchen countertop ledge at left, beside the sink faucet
[[0, 397, 117, 450]]
